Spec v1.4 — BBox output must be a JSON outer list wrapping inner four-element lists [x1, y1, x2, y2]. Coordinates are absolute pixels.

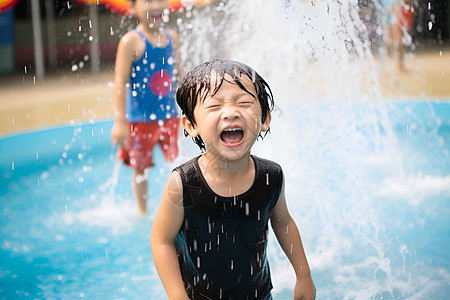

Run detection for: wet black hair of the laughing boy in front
[[176, 59, 274, 149]]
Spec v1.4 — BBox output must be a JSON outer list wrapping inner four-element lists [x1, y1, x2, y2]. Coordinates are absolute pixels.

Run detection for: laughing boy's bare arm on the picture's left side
[[150, 172, 189, 300]]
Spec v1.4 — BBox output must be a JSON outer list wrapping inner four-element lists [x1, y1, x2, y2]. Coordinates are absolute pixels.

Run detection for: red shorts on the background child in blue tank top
[[117, 118, 180, 171]]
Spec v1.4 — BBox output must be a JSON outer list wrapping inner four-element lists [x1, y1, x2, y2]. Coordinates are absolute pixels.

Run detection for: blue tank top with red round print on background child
[[126, 28, 178, 123]]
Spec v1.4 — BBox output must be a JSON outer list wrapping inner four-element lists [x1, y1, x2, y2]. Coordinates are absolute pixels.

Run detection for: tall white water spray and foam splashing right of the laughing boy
[[175, 0, 450, 299]]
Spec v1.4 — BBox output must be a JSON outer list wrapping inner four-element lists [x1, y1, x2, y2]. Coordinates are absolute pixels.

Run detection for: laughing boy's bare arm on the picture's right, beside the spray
[[270, 179, 316, 300]]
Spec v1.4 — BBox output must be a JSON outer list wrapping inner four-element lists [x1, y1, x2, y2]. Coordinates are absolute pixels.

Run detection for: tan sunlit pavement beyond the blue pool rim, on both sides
[[0, 47, 450, 136]]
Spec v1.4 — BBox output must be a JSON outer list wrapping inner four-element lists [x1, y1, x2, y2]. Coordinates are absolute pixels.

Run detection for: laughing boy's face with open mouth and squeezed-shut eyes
[[182, 71, 270, 160]]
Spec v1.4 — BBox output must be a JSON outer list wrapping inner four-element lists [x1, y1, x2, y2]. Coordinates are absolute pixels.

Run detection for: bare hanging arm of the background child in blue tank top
[[111, 33, 135, 148]]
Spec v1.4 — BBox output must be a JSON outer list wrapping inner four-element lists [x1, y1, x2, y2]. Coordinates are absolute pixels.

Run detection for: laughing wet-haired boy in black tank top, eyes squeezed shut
[[151, 60, 315, 300]]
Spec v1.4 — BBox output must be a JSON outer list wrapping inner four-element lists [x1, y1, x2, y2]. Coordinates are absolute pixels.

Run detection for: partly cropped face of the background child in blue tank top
[[130, 0, 169, 28]]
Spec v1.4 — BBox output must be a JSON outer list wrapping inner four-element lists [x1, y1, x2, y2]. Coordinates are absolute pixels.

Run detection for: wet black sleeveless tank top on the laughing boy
[[175, 156, 283, 300]]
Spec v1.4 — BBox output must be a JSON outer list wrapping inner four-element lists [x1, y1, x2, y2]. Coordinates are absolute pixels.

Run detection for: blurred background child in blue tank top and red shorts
[[111, 0, 181, 214]]
